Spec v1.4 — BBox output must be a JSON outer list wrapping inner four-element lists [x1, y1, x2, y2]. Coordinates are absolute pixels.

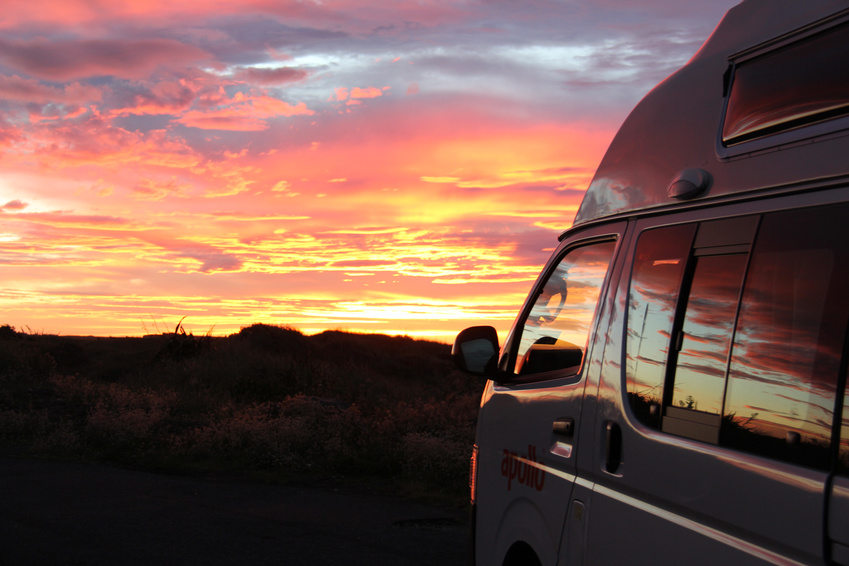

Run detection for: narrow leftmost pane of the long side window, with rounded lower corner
[[625, 224, 696, 428]]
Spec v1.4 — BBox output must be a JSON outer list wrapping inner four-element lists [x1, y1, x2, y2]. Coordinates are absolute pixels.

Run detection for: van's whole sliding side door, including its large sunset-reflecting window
[[581, 205, 849, 565]]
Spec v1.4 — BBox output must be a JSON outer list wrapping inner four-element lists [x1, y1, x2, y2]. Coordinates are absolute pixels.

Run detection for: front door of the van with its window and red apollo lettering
[[475, 223, 624, 564]]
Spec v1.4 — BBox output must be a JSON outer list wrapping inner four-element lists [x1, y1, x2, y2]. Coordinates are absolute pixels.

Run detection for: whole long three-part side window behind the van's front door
[[625, 205, 849, 473]]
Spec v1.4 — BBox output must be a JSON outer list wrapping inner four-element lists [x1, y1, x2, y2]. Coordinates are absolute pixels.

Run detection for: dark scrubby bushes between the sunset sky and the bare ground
[[0, 324, 481, 501]]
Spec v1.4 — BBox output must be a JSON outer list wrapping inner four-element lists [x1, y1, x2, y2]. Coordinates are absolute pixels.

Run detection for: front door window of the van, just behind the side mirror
[[515, 241, 616, 376]]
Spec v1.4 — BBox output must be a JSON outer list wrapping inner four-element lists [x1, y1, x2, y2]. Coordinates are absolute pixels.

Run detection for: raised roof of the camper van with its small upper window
[[574, 0, 849, 225]]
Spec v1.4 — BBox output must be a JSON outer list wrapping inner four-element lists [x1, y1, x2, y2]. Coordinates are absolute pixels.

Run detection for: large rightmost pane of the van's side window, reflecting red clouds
[[721, 207, 849, 467]]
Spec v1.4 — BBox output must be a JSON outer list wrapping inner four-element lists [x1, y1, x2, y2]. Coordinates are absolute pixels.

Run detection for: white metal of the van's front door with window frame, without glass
[[475, 222, 625, 564]]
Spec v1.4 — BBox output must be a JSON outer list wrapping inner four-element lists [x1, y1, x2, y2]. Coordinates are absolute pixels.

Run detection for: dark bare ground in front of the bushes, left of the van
[[0, 454, 467, 566]]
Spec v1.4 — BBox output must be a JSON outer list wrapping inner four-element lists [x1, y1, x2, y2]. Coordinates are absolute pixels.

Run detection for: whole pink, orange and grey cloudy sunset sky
[[0, 0, 738, 342]]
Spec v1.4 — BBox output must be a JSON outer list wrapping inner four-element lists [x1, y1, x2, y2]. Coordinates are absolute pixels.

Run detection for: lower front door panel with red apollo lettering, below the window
[[475, 380, 584, 564]]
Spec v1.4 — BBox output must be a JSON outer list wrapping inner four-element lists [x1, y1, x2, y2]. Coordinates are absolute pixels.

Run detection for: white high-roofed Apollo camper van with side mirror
[[453, 0, 849, 566]]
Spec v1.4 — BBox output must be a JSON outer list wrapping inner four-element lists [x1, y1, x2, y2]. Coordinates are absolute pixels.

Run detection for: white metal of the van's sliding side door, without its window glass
[[582, 202, 828, 564]]
